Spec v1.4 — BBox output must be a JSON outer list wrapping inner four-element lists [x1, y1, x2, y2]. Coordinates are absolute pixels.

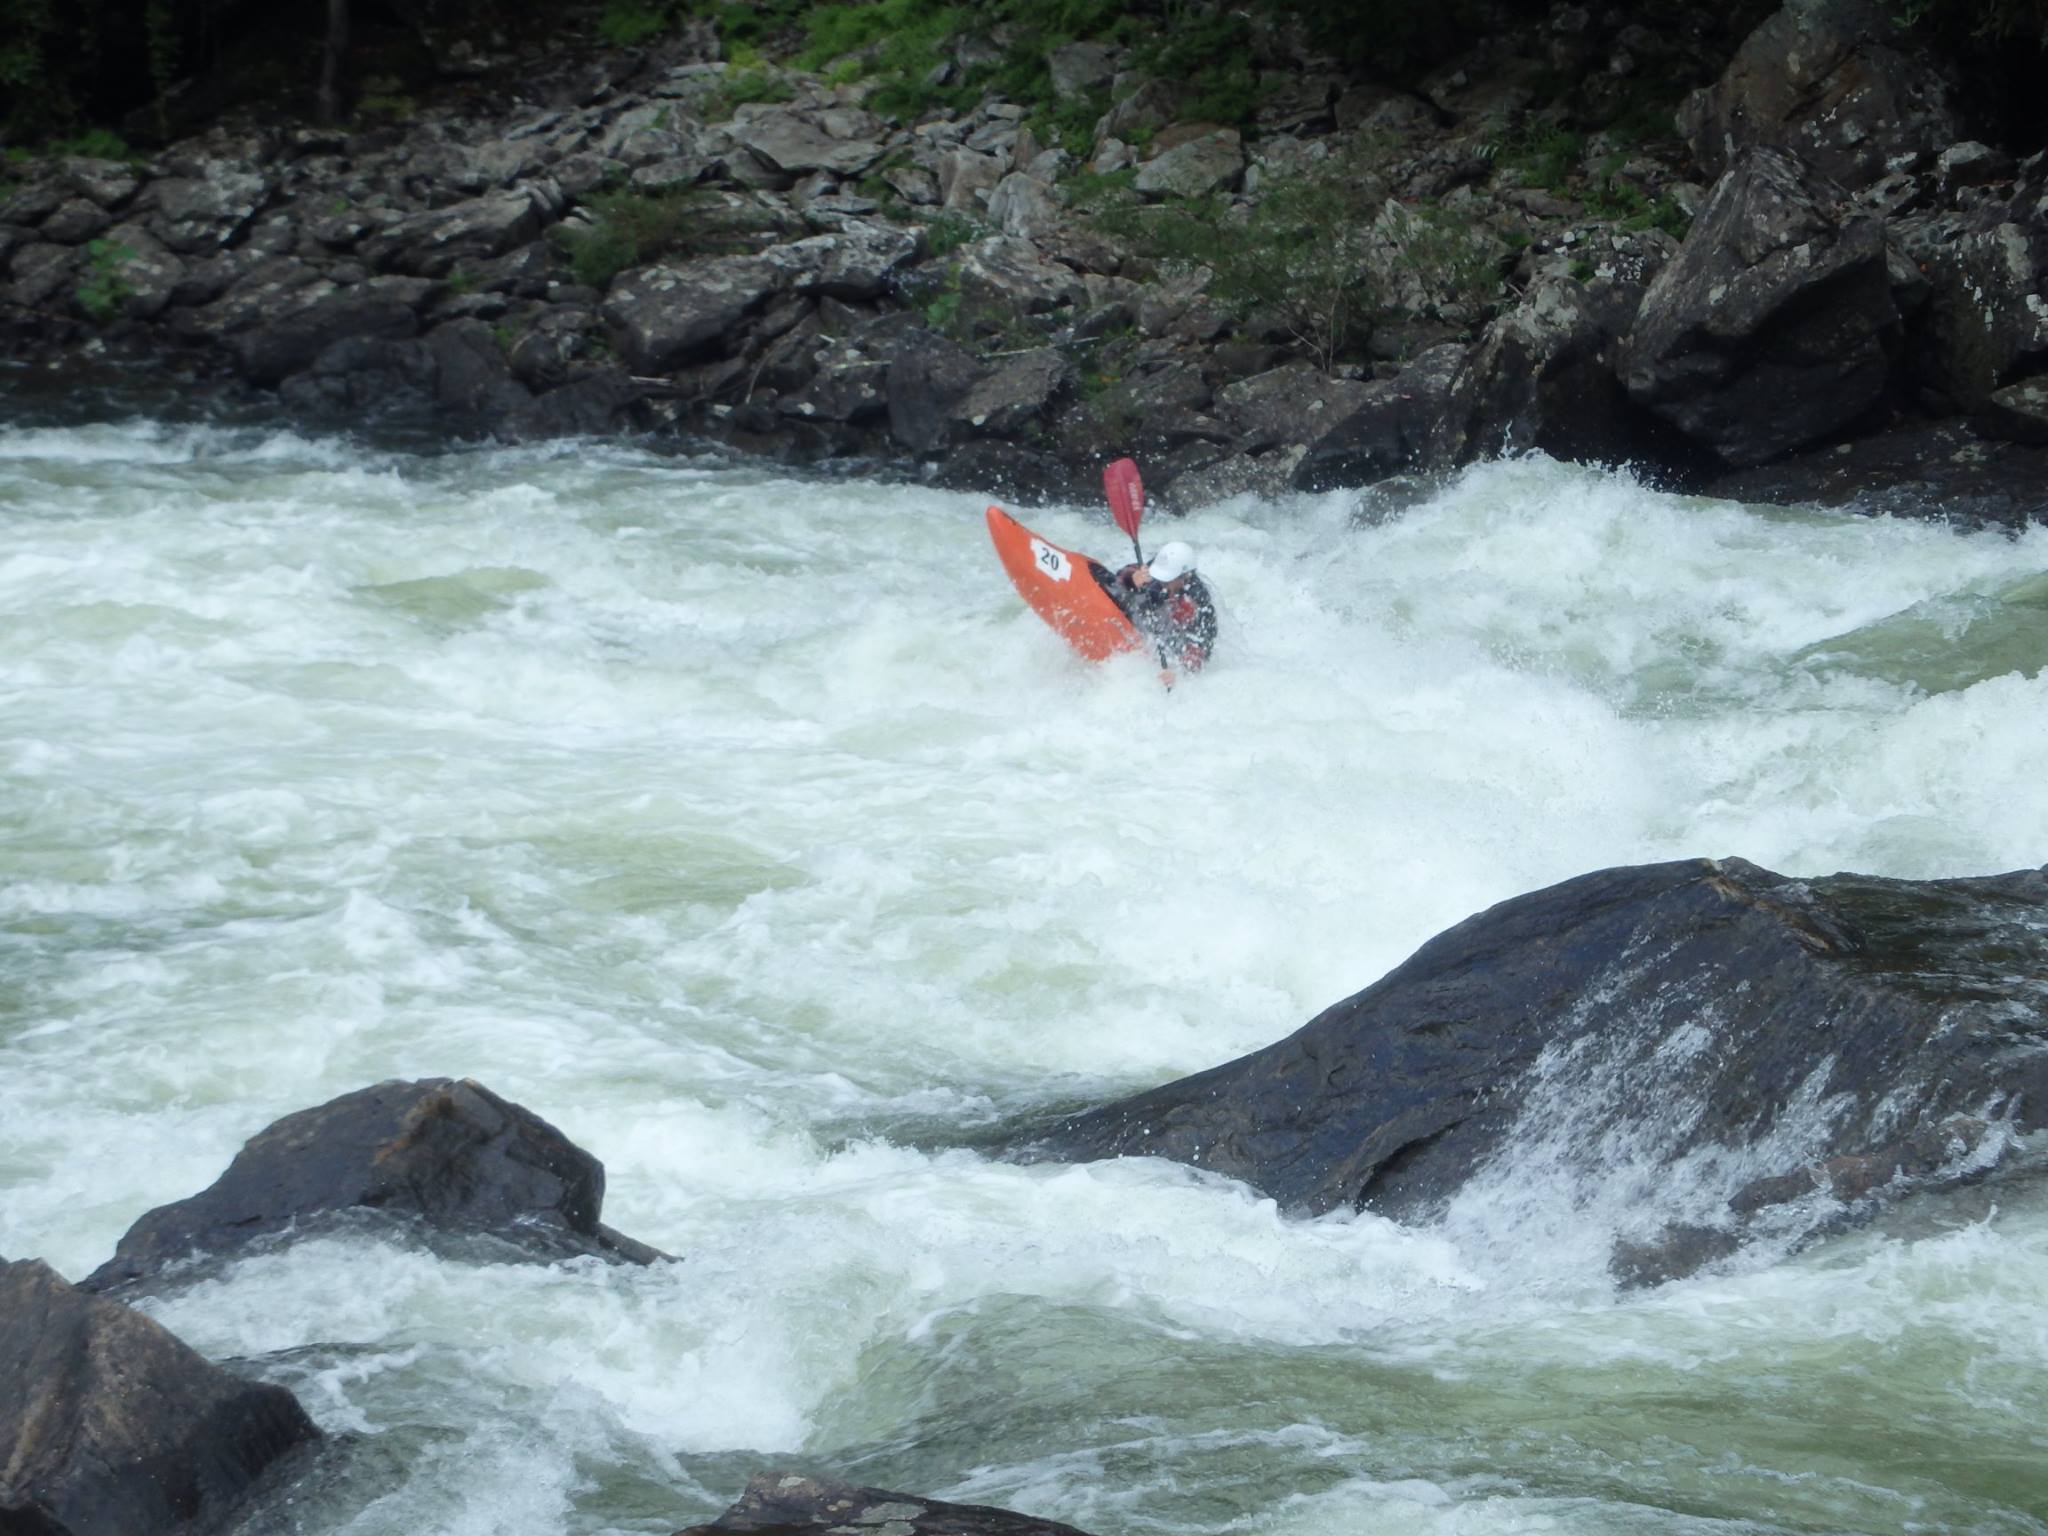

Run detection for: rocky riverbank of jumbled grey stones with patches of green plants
[[0, 0, 2048, 522]]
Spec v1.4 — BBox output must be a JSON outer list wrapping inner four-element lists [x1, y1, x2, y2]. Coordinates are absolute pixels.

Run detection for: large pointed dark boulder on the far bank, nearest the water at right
[[1622, 150, 1898, 467]]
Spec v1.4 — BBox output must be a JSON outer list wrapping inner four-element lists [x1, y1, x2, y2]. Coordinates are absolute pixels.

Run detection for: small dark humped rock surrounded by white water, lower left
[[84, 1077, 662, 1290]]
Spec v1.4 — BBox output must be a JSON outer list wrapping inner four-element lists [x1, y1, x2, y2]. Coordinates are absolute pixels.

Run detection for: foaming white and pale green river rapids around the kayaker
[[0, 422, 2048, 1536]]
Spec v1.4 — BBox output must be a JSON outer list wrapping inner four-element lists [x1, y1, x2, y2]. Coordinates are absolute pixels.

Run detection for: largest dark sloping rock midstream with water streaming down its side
[[1014, 860, 2048, 1277]]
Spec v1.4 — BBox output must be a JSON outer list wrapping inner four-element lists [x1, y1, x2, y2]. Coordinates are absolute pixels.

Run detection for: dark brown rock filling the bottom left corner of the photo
[[0, 1260, 319, 1536]]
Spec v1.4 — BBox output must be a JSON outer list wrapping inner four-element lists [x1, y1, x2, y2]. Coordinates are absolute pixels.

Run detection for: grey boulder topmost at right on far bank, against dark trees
[[1679, 0, 1962, 186]]
